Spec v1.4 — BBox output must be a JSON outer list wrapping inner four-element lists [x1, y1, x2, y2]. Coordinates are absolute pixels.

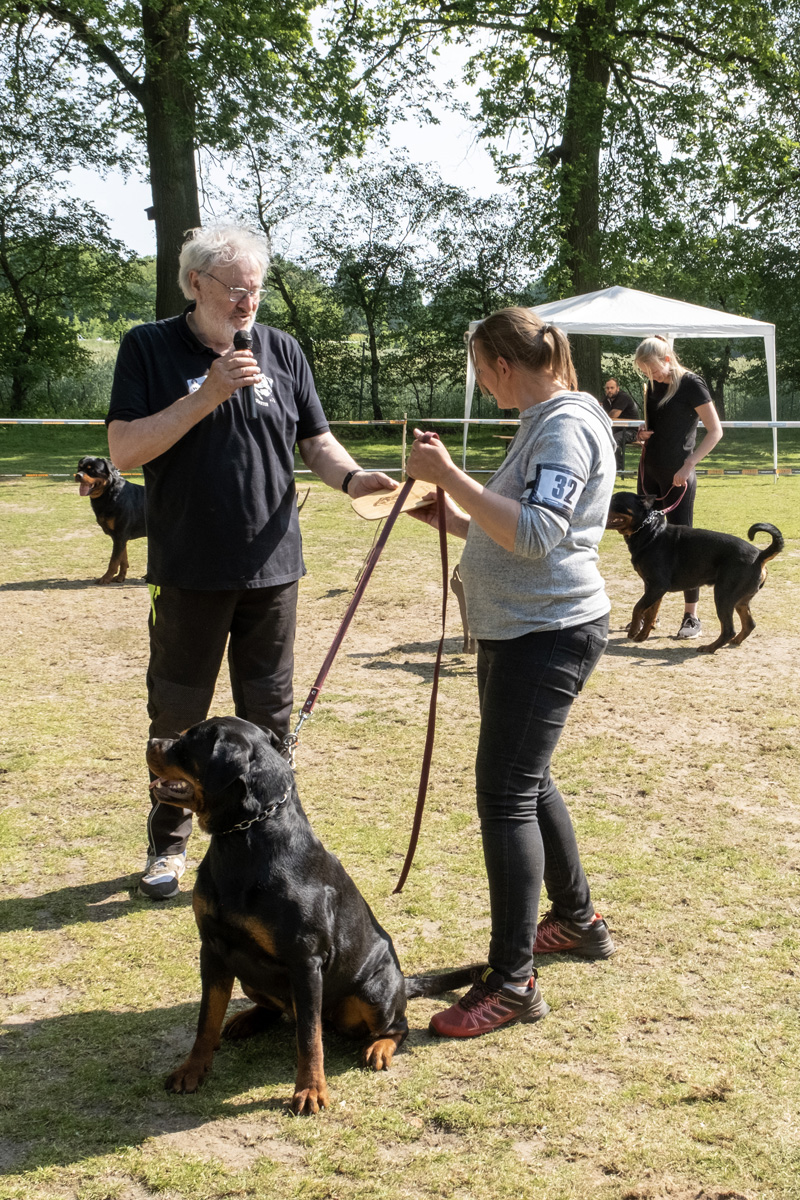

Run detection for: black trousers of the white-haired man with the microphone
[[148, 582, 297, 856]]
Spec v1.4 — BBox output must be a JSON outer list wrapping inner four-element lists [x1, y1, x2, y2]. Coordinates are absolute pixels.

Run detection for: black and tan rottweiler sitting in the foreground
[[148, 716, 470, 1112]]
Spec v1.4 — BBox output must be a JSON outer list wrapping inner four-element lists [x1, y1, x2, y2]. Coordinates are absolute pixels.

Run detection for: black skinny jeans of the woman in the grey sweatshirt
[[475, 616, 608, 984]]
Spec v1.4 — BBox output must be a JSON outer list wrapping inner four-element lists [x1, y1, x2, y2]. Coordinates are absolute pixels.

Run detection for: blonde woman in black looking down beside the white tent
[[633, 337, 722, 638]]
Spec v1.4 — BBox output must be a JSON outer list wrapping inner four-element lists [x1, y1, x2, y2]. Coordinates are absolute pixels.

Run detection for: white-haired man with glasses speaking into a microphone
[[107, 226, 397, 900]]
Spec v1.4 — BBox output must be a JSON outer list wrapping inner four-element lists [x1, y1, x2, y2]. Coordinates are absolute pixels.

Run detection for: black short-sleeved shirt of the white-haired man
[[106, 305, 329, 592]]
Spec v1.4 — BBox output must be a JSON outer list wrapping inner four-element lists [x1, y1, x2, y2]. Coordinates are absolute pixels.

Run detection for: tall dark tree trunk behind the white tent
[[559, 0, 615, 396]]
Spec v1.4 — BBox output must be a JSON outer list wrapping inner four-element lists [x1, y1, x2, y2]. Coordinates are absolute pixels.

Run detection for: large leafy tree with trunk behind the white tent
[[362, 0, 800, 398]]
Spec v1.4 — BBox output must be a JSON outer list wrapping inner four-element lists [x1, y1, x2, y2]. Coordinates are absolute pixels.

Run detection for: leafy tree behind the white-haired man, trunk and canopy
[[0, 0, 388, 317]]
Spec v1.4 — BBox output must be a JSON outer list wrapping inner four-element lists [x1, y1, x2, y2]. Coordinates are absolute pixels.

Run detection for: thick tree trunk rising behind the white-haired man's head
[[142, 0, 200, 320]]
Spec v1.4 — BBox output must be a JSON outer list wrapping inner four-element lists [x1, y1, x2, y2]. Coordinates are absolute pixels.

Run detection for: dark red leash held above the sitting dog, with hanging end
[[281, 478, 447, 893]]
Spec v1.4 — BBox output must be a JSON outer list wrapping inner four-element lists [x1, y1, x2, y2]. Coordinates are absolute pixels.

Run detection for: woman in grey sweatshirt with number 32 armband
[[408, 308, 615, 1037]]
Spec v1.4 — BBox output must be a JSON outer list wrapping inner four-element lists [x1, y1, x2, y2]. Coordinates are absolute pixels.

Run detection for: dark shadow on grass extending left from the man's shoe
[[0, 875, 192, 932]]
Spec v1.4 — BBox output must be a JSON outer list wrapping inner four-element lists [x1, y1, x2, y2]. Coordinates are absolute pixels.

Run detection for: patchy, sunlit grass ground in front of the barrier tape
[[0, 465, 800, 1200]]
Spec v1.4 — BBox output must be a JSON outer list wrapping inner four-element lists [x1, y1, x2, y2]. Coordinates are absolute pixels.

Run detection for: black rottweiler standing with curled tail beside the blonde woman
[[606, 492, 783, 654]]
